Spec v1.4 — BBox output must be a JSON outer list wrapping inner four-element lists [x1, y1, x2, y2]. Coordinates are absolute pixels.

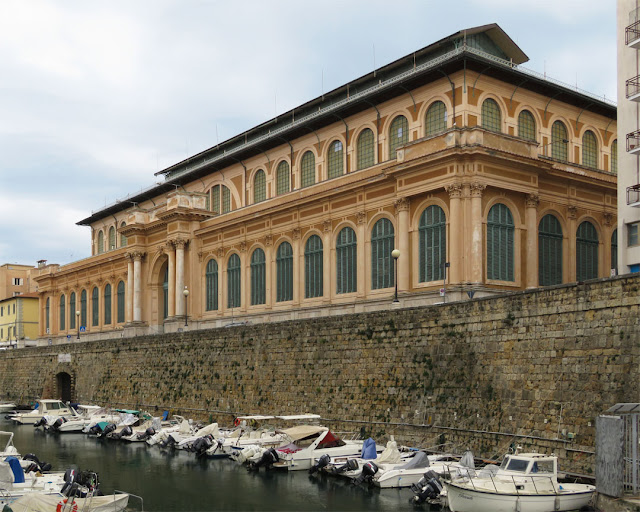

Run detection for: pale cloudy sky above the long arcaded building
[[0, 0, 616, 265]]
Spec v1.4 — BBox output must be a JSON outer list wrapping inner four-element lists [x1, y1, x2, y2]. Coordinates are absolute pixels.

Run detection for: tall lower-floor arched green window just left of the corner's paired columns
[[418, 205, 447, 283]]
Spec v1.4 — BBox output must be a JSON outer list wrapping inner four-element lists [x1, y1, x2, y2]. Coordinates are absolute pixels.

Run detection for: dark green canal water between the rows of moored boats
[[0, 419, 436, 512]]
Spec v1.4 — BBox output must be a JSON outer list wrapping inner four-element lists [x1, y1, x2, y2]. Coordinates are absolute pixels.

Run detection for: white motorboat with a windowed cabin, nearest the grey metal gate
[[443, 453, 596, 512]]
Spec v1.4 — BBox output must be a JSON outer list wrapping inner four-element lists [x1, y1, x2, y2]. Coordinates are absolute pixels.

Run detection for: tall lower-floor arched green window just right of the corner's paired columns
[[487, 203, 515, 281]]
